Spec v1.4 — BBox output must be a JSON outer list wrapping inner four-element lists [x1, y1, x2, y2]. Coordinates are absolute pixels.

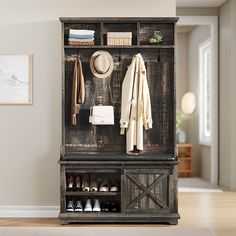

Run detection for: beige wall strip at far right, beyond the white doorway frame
[[219, 0, 236, 189]]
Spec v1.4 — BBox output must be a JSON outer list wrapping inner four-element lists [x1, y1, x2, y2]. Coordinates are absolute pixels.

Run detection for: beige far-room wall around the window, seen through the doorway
[[176, 26, 211, 177]]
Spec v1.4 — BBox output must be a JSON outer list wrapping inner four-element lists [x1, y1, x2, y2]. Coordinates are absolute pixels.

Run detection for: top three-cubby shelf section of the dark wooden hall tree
[[60, 17, 178, 49]]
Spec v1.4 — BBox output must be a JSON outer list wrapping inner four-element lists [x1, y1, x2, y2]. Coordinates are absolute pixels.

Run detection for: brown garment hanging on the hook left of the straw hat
[[71, 58, 85, 125]]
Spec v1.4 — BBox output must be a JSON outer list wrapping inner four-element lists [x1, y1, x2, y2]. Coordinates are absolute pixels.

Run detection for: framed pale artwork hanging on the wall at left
[[0, 55, 32, 105]]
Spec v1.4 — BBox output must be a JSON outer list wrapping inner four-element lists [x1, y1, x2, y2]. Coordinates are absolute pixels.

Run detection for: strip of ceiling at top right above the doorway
[[176, 0, 226, 7]]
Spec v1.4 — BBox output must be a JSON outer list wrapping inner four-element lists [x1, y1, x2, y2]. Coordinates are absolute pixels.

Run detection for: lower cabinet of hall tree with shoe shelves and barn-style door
[[59, 161, 179, 224]]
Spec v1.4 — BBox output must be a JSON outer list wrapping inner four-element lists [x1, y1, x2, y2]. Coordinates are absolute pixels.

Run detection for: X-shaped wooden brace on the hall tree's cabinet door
[[126, 174, 167, 208]]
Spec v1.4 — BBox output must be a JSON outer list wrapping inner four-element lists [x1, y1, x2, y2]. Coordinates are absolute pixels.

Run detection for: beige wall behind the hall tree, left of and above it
[[0, 0, 176, 206]]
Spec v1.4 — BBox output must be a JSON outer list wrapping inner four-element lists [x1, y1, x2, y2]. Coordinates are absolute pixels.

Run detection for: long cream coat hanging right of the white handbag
[[120, 53, 152, 154]]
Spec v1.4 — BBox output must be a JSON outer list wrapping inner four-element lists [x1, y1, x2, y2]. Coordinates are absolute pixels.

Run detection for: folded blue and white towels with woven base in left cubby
[[68, 29, 95, 46]]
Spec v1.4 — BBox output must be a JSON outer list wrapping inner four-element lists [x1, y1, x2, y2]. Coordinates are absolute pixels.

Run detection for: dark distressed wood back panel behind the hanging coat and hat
[[65, 49, 175, 154]]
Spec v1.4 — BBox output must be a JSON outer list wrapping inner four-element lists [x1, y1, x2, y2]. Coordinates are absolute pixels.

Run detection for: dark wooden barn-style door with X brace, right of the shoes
[[123, 168, 170, 213]]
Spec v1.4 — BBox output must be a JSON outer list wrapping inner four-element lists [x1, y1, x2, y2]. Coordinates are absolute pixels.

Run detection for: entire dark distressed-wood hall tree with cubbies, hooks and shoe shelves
[[59, 18, 179, 224]]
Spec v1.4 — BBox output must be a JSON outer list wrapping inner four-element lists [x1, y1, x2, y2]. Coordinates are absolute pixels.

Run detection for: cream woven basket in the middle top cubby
[[107, 32, 132, 46]]
